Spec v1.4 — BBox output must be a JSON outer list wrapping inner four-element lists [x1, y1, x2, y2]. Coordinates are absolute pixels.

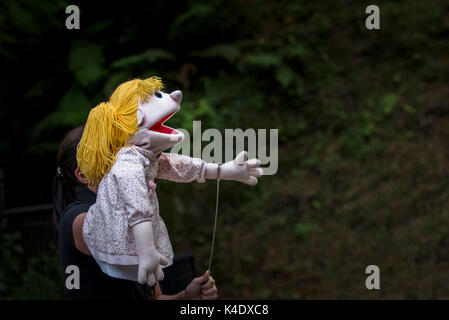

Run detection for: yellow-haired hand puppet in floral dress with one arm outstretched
[[77, 77, 262, 286]]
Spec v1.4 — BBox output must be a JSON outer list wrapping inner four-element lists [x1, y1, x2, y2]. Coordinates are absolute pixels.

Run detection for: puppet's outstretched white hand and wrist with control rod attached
[[206, 151, 263, 186]]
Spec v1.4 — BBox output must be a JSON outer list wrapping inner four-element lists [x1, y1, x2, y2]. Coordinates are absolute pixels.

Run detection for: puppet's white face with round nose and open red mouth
[[133, 90, 184, 148]]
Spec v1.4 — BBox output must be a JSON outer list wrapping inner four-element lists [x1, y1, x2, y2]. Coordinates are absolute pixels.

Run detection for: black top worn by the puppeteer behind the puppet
[[59, 185, 149, 300]]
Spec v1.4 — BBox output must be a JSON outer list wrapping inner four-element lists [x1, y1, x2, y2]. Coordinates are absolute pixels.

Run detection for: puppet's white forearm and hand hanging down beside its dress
[[133, 221, 168, 286]]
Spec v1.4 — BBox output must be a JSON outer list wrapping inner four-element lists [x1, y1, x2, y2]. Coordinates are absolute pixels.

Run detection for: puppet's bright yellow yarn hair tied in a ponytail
[[76, 77, 162, 187]]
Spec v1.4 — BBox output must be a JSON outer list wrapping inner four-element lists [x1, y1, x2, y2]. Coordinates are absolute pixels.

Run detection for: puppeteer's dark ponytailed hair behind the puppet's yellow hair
[[53, 125, 84, 229]]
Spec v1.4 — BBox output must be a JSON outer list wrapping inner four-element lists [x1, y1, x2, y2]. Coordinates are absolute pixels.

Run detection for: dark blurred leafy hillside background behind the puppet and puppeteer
[[0, 0, 449, 299]]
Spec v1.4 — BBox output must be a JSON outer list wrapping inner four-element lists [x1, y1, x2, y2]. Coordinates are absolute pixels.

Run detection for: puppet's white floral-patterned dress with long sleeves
[[83, 146, 205, 281]]
